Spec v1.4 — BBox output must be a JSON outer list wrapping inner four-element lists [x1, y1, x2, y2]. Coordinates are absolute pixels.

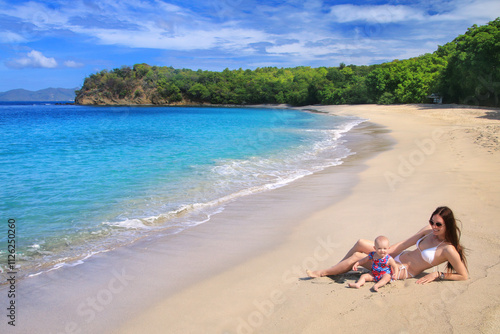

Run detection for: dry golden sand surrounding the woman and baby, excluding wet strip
[[113, 105, 500, 333]]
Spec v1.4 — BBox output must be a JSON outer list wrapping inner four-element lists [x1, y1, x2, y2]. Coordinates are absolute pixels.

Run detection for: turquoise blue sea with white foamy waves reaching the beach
[[0, 103, 363, 276]]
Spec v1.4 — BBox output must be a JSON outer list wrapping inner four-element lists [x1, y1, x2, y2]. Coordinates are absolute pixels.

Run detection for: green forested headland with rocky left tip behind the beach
[[76, 18, 500, 106]]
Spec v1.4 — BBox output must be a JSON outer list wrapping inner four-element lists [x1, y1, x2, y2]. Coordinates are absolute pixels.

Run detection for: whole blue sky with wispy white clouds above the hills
[[0, 0, 500, 92]]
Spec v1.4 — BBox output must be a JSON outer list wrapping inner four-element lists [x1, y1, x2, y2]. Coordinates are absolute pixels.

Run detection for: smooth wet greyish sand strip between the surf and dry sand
[[0, 106, 389, 332]]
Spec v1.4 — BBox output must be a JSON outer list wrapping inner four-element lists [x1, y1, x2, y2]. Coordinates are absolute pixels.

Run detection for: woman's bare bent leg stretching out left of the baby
[[306, 239, 374, 277]]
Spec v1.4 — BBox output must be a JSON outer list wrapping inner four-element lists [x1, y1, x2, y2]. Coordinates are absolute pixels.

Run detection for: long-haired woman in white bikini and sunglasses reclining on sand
[[307, 206, 468, 284]]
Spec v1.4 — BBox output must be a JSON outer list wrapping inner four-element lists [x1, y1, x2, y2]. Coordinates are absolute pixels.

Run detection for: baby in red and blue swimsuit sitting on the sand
[[349, 236, 398, 292]]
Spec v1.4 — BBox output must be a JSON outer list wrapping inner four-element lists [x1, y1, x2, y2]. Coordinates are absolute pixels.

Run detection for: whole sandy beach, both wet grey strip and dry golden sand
[[0, 105, 500, 333]]
